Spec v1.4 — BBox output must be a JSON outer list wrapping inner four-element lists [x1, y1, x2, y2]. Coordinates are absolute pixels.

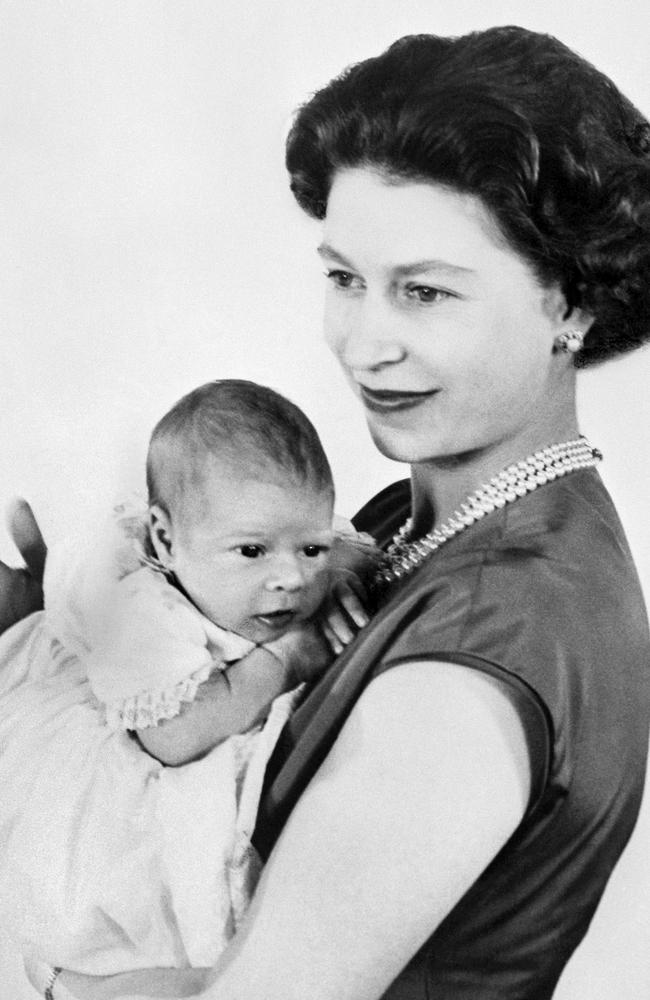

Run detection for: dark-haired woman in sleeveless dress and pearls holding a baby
[[7, 21, 650, 1000]]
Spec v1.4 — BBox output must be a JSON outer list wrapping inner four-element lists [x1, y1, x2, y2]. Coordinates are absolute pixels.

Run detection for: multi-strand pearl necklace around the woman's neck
[[373, 436, 603, 587]]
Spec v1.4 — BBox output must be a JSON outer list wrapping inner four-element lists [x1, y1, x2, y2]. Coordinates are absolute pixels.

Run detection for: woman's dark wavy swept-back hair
[[286, 27, 650, 366]]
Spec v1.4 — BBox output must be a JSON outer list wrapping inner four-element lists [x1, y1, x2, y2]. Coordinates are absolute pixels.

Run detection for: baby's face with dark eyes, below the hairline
[[167, 464, 333, 642]]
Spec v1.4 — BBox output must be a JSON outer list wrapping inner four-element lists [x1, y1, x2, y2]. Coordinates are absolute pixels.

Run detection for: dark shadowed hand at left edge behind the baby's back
[[0, 500, 47, 632]]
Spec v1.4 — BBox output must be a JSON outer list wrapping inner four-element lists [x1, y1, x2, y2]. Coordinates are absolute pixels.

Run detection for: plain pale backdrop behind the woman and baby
[[0, 0, 650, 1000]]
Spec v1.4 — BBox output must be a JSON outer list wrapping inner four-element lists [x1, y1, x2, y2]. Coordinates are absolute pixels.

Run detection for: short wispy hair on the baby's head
[[147, 379, 334, 513]]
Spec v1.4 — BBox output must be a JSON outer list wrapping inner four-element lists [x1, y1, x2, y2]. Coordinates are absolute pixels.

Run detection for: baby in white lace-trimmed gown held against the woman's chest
[[0, 381, 374, 975]]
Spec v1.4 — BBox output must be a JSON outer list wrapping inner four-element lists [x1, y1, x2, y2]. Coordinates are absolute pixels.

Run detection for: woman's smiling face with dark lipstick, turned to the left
[[319, 169, 576, 462]]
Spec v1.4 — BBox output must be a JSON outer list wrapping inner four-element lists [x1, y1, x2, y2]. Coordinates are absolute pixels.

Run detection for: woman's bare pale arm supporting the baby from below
[[46, 662, 530, 1000]]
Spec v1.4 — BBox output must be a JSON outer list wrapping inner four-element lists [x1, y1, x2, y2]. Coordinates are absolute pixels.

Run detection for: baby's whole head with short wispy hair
[[147, 379, 334, 642]]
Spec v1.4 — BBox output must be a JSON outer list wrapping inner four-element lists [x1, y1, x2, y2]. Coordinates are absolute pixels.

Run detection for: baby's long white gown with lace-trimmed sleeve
[[0, 508, 298, 976]]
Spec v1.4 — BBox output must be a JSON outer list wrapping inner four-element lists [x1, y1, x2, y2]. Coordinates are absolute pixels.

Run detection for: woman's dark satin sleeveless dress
[[254, 470, 650, 1000]]
